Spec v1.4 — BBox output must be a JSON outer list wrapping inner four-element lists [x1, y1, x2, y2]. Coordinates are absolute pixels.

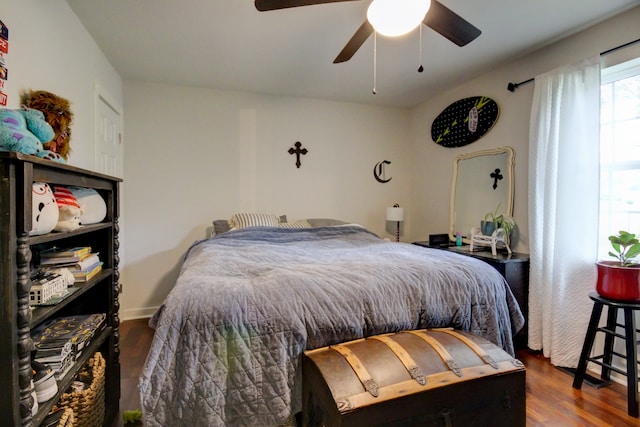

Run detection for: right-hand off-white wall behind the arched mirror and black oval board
[[409, 7, 640, 253]]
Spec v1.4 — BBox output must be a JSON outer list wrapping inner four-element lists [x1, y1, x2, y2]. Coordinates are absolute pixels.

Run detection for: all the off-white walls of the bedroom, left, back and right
[[7, 0, 640, 318]]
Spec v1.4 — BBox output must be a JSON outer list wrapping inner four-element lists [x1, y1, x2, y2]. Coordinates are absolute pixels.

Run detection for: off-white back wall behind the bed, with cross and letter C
[[121, 81, 411, 318]]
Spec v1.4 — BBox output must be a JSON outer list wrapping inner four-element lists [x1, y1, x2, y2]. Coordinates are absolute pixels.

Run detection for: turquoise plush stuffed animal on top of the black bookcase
[[0, 108, 64, 161]]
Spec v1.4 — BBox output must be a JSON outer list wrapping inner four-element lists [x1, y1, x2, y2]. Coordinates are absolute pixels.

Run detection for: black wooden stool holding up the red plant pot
[[573, 292, 640, 418]]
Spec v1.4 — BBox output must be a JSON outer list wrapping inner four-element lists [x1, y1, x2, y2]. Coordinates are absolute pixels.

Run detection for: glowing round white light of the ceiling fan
[[367, 0, 431, 37]]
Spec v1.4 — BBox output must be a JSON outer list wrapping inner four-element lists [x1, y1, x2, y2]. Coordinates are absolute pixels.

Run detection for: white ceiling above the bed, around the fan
[[67, 0, 639, 107]]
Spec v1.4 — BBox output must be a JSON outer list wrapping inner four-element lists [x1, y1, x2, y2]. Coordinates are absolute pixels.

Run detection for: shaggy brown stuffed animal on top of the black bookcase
[[22, 90, 73, 160]]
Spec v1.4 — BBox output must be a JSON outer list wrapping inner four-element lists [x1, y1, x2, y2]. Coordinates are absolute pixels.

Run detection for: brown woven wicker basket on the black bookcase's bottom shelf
[[59, 352, 106, 427]]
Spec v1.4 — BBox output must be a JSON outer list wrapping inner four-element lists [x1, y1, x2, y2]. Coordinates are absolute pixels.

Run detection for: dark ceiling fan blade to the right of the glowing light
[[422, 0, 482, 46]]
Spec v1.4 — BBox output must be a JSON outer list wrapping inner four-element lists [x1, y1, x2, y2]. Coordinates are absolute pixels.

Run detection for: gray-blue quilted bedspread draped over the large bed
[[139, 226, 523, 427]]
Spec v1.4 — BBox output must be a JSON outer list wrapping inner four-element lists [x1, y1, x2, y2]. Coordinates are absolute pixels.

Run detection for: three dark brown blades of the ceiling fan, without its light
[[255, 0, 481, 64]]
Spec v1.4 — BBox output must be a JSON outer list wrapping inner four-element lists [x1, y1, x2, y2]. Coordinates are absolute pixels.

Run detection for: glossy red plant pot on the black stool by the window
[[596, 261, 640, 302]]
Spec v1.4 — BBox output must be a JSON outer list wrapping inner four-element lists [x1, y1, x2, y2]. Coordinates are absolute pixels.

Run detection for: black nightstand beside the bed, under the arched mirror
[[413, 241, 529, 348]]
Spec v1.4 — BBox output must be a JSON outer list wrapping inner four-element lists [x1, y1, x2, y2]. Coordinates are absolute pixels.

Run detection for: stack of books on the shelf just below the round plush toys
[[40, 246, 102, 283]]
